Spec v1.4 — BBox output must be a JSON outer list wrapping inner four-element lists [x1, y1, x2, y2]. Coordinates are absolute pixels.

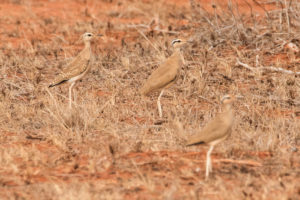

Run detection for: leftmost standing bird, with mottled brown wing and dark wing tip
[[49, 33, 101, 108]]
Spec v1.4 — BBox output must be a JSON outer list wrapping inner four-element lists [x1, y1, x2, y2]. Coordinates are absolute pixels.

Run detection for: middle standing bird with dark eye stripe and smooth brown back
[[140, 39, 187, 117]]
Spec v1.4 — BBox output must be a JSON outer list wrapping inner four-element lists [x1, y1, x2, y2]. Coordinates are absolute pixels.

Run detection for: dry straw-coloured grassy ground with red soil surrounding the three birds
[[0, 0, 300, 200]]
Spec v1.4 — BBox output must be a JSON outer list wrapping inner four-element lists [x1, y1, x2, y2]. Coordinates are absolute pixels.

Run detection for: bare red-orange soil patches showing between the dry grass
[[0, 0, 298, 199]]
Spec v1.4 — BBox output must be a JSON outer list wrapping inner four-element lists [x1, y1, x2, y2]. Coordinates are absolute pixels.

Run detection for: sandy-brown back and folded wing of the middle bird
[[140, 52, 181, 95]]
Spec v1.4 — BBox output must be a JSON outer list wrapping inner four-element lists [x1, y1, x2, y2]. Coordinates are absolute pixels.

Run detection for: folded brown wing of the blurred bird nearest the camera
[[187, 114, 232, 145]]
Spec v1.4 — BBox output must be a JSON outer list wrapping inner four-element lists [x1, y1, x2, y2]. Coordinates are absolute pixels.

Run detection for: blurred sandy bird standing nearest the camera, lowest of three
[[187, 95, 235, 180]]
